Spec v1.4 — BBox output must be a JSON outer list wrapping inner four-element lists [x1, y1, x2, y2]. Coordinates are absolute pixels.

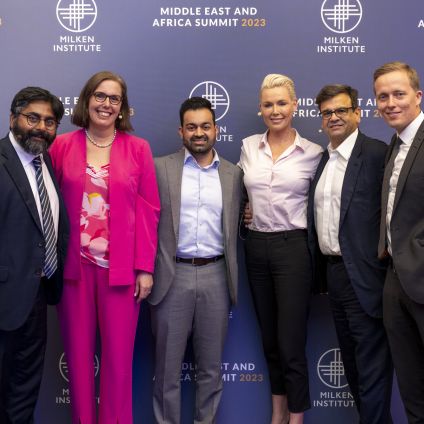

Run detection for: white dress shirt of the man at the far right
[[386, 112, 424, 255]]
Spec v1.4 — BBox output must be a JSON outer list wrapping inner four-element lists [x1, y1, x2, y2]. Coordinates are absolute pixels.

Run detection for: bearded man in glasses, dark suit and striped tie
[[0, 87, 68, 424]]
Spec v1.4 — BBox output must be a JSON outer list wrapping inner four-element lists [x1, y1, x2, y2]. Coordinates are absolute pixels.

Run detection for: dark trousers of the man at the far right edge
[[383, 266, 424, 424]]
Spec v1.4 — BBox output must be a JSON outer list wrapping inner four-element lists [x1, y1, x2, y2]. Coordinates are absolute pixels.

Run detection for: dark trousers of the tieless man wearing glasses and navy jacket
[[327, 258, 393, 424]]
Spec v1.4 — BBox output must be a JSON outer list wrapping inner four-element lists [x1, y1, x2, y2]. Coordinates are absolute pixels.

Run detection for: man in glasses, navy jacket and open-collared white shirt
[[308, 85, 393, 424]]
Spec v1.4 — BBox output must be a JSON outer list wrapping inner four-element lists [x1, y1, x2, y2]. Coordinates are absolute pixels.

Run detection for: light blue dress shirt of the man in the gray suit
[[177, 149, 224, 258]]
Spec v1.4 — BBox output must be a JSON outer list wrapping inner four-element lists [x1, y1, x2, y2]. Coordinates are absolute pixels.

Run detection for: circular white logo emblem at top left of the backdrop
[[56, 0, 97, 32]]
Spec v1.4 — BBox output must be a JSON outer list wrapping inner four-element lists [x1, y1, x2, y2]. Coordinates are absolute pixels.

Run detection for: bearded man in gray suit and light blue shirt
[[148, 97, 242, 424]]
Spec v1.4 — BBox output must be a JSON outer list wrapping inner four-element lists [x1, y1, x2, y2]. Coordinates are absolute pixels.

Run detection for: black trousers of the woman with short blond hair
[[245, 230, 311, 412]]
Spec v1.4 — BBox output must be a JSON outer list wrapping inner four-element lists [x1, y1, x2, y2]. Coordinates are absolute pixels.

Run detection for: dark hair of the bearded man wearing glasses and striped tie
[[10, 87, 65, 122]]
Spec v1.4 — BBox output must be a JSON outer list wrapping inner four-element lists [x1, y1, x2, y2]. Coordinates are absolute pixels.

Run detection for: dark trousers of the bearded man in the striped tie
[[0, 286, 47, 424]]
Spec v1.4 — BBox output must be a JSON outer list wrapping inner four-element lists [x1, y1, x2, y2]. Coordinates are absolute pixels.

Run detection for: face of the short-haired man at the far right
[[374, 71, 422, 133]]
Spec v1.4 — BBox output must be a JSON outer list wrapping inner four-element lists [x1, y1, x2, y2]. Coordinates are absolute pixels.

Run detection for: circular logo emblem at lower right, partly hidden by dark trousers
[[317, 348, 348, 389]]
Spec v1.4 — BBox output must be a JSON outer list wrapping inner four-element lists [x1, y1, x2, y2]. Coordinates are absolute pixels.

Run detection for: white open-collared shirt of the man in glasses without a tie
[[314, 130, 359, 256]]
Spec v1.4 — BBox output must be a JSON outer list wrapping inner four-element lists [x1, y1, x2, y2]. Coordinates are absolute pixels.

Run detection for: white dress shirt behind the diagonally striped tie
[[9, 132, 59, 241]]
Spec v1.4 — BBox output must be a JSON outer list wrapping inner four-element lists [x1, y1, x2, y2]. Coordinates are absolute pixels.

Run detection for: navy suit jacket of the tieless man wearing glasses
[[308, 132, 387, 317]]
